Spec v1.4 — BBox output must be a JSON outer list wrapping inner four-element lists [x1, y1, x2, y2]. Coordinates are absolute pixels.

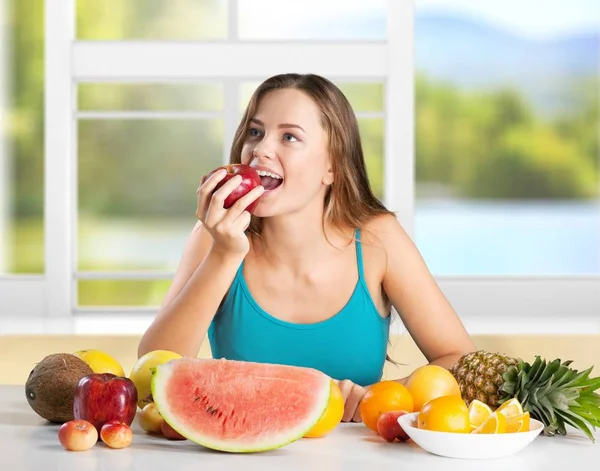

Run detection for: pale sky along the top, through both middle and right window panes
[[239, 0, 600, 39]]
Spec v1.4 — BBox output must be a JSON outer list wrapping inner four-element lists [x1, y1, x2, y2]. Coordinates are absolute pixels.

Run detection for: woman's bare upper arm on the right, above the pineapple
[[370, 216, 476, 382]]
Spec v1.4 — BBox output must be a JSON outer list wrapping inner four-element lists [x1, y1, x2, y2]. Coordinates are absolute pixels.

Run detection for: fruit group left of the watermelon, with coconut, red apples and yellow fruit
[[25, 350, 184, 451]]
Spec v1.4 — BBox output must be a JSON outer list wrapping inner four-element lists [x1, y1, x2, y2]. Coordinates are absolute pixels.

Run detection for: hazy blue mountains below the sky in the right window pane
[[415, 13, 600, 113]]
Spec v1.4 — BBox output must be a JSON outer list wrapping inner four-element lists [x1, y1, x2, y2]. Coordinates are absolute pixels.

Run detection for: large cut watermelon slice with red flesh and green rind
[[151, 357, 331, 453]]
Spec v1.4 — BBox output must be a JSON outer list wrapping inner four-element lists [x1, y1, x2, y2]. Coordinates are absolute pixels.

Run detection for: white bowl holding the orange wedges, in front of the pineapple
[[398, 412, 544, 460]]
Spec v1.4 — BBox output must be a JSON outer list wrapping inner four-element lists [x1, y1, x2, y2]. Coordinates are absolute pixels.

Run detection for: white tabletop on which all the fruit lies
[[0, 385, 600, 471]]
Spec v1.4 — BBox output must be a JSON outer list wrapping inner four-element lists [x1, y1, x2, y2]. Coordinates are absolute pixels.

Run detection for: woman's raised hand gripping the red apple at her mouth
[[196, 169, 264, 255]]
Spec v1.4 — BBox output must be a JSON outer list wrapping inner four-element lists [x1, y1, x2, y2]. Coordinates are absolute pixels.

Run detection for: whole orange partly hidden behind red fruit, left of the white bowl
[[360, 381, 414, 433]]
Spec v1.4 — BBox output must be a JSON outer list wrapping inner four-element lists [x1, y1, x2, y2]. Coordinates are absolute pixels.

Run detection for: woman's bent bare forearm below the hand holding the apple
[[138, 222, 244, 357]]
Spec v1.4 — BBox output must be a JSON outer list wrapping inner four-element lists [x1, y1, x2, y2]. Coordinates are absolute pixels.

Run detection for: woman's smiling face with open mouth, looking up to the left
[[241, 89, 333, 217]]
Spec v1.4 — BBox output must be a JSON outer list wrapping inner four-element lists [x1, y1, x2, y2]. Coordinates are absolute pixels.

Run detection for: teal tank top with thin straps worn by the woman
[[208, 230, 390, 386]]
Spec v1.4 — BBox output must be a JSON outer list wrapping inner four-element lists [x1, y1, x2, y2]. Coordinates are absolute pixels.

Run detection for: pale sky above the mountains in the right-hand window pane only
[[418, 0, 600, 38]]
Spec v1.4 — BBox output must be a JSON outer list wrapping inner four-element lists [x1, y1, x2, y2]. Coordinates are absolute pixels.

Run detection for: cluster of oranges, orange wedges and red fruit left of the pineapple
[[360, 365, 530, 442]]
